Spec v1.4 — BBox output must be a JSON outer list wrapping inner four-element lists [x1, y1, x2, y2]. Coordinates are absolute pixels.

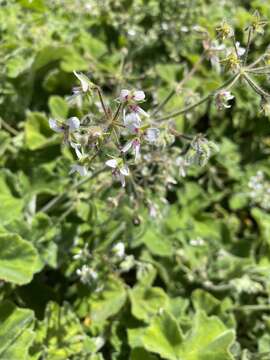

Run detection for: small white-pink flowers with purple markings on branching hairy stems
[[44, 15, 270, 217]]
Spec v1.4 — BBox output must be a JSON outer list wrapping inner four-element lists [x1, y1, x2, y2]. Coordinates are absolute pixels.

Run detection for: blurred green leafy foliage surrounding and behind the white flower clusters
[[0, 0, 270, 360]]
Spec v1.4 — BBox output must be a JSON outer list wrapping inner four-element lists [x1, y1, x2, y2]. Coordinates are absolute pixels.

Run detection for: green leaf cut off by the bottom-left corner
[[0, 301, 34, 360]]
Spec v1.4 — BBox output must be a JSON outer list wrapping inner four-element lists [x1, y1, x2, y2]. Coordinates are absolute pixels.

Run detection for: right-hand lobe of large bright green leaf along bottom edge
[[178, 311, 235, 360]]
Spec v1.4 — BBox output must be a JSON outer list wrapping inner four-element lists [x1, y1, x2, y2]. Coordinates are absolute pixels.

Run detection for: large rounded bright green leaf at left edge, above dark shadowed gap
[[0, 234, 40, 285]]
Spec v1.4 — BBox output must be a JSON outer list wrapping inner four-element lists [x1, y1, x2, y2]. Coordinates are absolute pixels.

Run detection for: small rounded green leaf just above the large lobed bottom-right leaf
[[129, 286, 169, 321]]
